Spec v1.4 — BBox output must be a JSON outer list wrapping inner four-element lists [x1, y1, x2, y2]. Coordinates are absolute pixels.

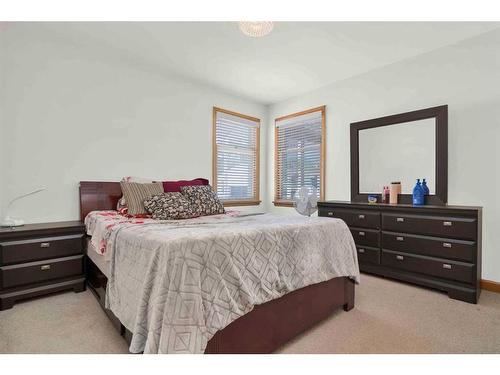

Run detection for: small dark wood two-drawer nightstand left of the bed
[[0, 221, 85, 310]]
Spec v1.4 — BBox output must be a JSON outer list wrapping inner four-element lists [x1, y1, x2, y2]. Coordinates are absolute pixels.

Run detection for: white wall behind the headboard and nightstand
[[0, 27, 267, 222]]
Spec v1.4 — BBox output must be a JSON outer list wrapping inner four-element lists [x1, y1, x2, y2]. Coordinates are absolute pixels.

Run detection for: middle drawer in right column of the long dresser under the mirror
[[382, 232, 476, 262]]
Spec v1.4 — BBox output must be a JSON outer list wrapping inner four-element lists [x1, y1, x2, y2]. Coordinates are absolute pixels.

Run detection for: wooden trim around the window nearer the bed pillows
[[212, 107, 261, 207]]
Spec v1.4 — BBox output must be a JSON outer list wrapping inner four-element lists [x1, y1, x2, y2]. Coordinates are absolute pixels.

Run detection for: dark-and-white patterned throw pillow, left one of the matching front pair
[[144, 193, 198, 220]]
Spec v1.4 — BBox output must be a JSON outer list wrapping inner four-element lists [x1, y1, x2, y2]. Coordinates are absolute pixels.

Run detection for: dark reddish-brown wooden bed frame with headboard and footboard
[[80, 181, 354, 353]]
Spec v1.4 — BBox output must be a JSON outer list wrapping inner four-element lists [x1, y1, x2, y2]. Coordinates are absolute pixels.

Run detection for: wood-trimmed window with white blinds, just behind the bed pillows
[[212, 107, 260, 206]]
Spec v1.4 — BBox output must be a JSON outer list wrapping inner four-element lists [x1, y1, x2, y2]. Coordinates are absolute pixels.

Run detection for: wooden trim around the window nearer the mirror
[[273, 105, 326, 207]]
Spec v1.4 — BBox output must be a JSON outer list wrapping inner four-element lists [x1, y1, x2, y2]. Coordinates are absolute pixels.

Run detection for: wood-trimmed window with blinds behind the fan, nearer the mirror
[[274, 106, 325, 206]]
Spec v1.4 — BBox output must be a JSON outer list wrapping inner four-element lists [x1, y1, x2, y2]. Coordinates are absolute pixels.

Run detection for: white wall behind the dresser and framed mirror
[[267, 30, 500, 281]]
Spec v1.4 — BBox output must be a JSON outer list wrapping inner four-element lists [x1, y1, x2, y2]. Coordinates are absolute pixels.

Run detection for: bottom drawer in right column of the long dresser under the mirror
[[381, 250, 474, 283]]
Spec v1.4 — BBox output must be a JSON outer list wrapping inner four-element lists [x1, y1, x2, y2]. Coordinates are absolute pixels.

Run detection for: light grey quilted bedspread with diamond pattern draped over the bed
[[86, 213, 359, 353]]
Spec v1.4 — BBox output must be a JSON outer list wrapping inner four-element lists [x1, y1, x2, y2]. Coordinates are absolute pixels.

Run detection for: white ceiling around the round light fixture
[[8, 22, 500, 104]]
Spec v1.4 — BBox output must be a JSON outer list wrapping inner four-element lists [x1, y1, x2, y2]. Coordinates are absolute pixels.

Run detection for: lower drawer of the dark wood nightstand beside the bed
[[0, 255, 83, 289]]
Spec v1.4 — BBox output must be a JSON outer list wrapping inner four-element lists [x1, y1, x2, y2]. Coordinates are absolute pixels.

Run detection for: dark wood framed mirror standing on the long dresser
[[351, 105, 448, 205]]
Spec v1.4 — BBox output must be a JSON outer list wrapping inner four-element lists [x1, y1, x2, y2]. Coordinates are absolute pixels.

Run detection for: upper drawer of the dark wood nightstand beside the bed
[[0, 234, 83, 265]]
